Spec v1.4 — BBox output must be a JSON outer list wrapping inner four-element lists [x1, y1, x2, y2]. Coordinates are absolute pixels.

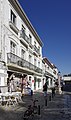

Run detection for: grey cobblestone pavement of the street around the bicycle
[[0, 92, 71, 120]]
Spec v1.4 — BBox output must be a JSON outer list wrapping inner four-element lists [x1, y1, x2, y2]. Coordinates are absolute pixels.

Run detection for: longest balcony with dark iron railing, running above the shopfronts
[[7, 53, 42, 73]]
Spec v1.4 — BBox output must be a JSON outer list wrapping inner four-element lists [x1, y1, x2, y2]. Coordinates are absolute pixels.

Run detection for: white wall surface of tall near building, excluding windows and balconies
[[0, 0, 42, 90]]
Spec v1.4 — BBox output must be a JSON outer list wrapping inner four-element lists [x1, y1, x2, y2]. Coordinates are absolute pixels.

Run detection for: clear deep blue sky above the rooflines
[[19, 0, 71, 75]]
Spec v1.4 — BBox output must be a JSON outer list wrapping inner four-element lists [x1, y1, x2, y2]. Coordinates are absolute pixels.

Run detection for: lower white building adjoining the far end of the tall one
[[43, 57, 58, 88]]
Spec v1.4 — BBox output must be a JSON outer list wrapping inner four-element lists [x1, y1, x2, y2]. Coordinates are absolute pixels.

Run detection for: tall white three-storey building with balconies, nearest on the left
[[0, 0, 42, 91]]
